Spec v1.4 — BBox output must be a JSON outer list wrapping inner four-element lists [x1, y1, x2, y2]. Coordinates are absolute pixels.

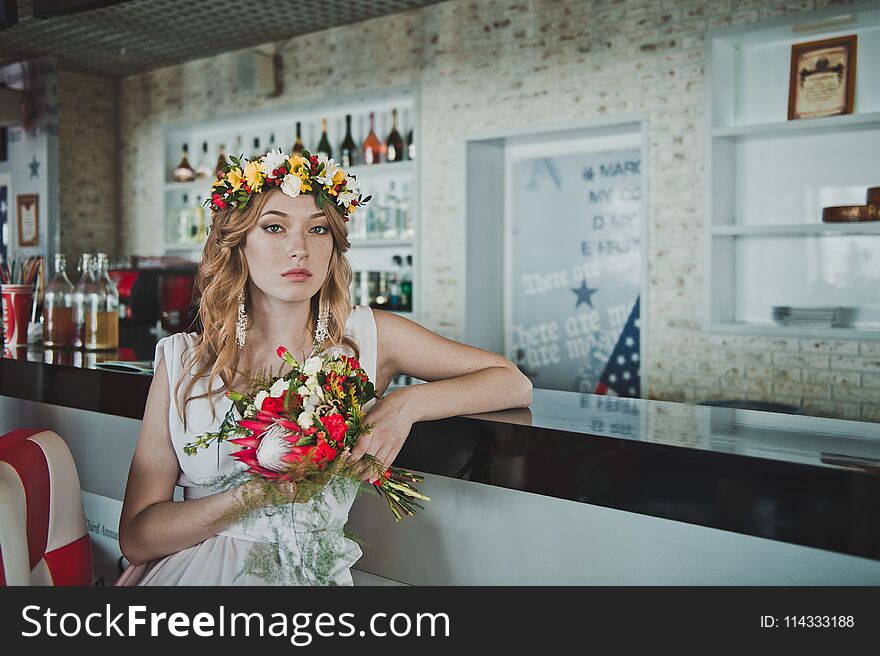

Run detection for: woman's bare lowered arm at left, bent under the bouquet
[[119, 359, 251, 565]]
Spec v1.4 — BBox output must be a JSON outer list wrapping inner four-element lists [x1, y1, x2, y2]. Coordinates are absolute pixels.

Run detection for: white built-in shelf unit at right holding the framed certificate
[[703, 2, 880, 341]]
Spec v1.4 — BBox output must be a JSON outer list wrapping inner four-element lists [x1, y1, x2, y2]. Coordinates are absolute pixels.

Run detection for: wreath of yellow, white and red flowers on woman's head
[[205, 148, 372, 221]]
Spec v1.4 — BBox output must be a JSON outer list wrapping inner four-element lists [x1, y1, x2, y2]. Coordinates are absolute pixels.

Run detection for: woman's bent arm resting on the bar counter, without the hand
[[373, 310, 532, 422]]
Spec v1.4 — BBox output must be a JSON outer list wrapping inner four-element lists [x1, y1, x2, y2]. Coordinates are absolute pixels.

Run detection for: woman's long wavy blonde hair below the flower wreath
[[174, 189, 360, 430]]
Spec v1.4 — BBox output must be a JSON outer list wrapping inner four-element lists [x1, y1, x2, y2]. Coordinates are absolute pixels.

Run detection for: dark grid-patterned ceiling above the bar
[[0, 0, 440, 77]]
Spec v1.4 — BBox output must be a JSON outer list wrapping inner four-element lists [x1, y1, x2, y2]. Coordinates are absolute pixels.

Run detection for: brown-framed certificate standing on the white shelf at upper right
[[788, 34, 857, 120]]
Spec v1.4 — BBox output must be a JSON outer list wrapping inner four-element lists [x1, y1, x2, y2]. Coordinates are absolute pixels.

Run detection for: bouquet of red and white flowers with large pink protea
[[184, 346, 430, 573]]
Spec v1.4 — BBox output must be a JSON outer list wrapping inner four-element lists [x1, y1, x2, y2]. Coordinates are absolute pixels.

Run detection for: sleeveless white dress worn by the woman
[[116, 305, 376, 585]]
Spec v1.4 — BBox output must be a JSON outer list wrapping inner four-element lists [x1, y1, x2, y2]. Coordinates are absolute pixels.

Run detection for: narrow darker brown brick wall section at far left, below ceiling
[[56, 72, 121, 268]]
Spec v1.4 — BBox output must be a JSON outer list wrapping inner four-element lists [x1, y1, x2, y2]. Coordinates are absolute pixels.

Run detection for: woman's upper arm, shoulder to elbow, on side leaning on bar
[[373, 309, 516, 382]]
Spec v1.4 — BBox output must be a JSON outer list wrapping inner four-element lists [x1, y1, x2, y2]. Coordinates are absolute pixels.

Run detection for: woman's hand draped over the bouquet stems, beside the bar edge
[[348, 390, 413, 483]]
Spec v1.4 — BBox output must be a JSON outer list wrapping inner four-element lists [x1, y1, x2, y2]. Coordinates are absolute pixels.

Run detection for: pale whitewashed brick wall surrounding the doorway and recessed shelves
[[120, 0, 880, 421]]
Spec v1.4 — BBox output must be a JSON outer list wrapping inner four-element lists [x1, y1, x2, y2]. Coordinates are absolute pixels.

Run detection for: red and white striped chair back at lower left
[[0, 428, 92, 586]]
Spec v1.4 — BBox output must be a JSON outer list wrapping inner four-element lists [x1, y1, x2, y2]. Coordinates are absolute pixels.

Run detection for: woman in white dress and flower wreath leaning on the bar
[[117, 150, 532, 585]]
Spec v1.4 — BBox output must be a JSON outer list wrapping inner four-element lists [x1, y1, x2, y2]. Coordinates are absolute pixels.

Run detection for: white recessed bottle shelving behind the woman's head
[[162, 87, 420, 317]]
